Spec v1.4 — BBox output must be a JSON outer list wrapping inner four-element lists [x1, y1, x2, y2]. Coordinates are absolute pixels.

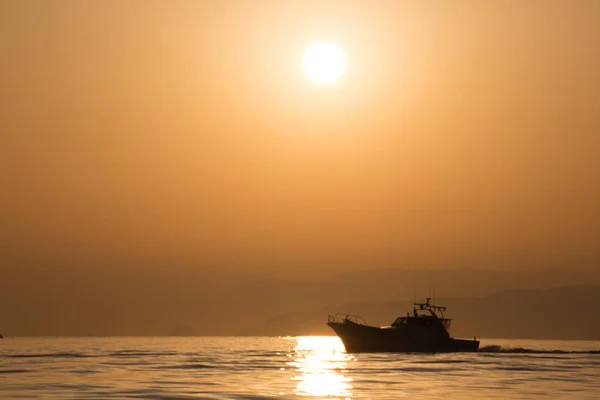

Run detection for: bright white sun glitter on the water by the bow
[[288, 336, 353, 398]]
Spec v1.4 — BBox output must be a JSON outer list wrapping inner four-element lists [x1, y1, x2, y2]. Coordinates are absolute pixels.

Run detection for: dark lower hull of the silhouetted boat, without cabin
[[327, 321, 479, 353]]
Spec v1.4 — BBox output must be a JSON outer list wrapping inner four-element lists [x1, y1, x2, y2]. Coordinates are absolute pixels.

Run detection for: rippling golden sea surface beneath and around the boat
[[0, 337, 600, 400]]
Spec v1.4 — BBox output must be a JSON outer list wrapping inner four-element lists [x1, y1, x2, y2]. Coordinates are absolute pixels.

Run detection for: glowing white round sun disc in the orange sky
[[302, 42, 346, 83]]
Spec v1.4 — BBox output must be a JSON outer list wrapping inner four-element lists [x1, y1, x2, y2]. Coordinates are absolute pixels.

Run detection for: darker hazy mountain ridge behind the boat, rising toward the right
[[260, 285, 600, 340]]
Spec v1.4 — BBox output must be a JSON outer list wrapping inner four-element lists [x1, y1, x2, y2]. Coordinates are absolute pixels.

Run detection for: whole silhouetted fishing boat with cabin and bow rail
[[327, 297, 479, 353]]
